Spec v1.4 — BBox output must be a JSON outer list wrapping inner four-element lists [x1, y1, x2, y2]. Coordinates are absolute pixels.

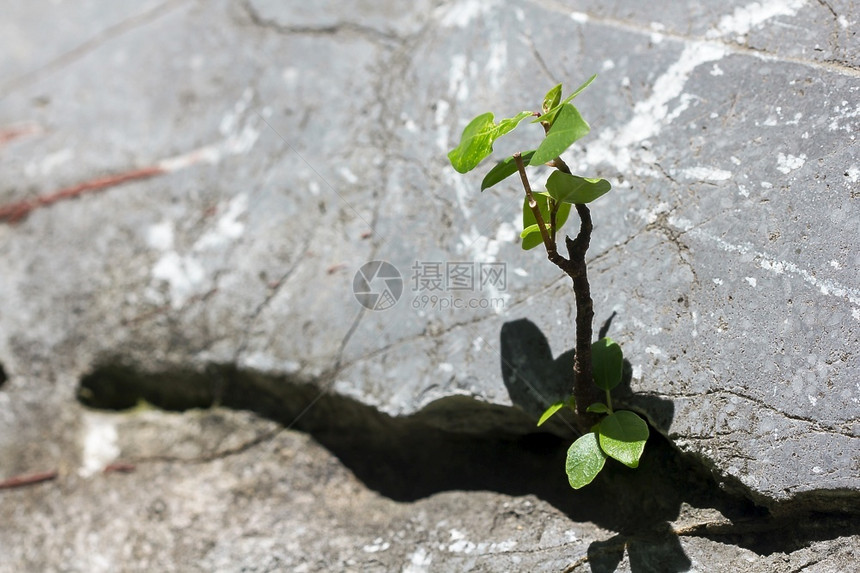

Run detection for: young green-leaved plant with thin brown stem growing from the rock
[[448, 76, 648, 489]]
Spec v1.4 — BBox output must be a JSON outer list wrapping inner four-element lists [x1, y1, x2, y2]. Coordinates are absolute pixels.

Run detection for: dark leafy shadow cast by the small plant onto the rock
[[501, 315, 720, 573]]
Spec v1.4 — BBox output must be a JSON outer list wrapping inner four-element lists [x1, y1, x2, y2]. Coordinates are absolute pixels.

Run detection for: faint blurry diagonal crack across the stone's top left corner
[[0, 0, 189, 100]]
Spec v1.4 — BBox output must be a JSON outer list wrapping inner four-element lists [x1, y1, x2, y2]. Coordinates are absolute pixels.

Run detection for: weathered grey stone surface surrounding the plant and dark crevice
[[0, 0, 860, 571]]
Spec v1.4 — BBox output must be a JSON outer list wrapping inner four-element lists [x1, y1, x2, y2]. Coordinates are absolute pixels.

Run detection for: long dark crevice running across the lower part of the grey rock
[[78, 361, 860, 571]]
